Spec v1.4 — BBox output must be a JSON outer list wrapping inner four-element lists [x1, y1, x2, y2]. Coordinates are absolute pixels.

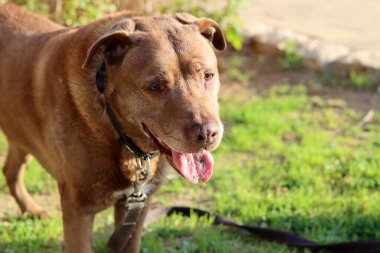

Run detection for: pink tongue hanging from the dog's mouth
[[172, 150, 214, 184]]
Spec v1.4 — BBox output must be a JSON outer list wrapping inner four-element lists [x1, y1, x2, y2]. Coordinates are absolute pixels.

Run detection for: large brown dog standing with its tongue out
[[0, 5, 226, 253]]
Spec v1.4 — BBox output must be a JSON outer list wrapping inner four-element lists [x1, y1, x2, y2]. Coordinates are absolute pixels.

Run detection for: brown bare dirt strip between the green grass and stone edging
[[218, 47, 380, 112]]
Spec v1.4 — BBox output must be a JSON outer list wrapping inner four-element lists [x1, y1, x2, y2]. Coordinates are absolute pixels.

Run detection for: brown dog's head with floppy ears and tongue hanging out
[[83, 13, 226, 183]]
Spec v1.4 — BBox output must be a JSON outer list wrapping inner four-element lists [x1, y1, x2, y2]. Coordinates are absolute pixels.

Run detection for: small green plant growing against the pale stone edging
[[278, 41, 303, 70]]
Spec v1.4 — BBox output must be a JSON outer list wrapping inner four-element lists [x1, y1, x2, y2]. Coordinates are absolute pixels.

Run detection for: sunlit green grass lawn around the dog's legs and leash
[[0, 85, 380, 253]]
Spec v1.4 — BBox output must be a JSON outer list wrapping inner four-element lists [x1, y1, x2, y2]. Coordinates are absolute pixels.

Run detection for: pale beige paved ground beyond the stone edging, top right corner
[[241, 0, 380, 52]]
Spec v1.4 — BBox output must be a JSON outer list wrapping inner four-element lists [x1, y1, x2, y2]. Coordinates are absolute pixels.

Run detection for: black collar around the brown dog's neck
[[96, 61, 160, 160]]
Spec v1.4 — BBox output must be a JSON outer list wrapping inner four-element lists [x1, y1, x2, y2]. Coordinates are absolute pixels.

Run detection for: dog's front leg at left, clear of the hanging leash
[[60, 187, 95, 253]]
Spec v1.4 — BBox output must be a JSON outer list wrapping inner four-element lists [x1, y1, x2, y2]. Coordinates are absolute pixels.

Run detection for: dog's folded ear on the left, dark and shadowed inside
[[82, 21, 139, 69]]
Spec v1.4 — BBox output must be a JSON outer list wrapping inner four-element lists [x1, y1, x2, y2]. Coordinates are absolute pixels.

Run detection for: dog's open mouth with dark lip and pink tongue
[[143, 124, 214, 184]]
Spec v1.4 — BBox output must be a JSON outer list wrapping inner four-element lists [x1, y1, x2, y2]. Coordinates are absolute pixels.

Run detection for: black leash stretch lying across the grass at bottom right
[[145, 206, 380, 253]]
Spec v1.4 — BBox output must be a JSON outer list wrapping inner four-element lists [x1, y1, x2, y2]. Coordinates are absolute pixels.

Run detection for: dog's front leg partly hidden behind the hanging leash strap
[[114, 198, 149, 253]]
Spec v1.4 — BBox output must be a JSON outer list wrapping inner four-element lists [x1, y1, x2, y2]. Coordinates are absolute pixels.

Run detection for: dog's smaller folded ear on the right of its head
[[175, 13, 227, 50]]
